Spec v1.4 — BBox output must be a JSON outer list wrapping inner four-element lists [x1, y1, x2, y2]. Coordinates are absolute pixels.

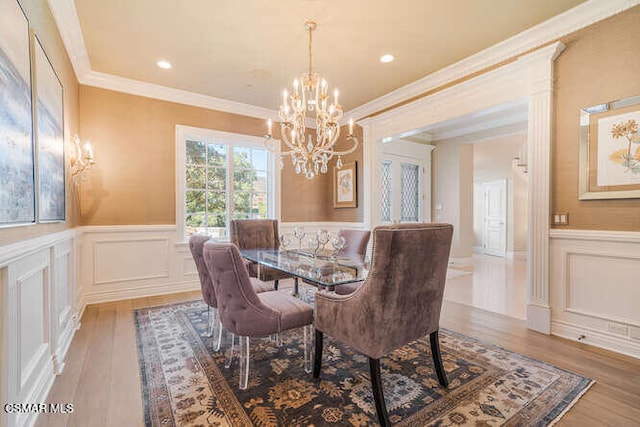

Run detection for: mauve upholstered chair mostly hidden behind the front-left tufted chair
[[189, 234, 271, 351]]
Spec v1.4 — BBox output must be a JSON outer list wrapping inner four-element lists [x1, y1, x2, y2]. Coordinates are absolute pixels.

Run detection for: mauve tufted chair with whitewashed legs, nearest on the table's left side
[[204, 241, 313, 390]]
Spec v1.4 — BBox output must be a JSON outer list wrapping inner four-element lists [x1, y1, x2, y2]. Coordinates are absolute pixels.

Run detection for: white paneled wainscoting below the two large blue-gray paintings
[[0, 229, 79, 427]]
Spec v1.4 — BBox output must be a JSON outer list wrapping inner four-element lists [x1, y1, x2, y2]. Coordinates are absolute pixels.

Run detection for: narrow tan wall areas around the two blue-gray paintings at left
[[0, 0, 78, 244]]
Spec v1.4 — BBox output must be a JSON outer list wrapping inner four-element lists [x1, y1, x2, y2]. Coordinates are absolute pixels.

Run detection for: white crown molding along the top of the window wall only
[[79, 71, 278, 120]]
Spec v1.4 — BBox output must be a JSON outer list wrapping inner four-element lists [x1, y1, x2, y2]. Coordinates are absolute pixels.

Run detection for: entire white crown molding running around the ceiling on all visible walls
[[47, 0, 640, 122]]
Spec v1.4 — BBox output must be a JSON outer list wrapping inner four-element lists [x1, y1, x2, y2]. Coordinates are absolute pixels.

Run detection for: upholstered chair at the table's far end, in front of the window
[[230, 219, 297, 293]]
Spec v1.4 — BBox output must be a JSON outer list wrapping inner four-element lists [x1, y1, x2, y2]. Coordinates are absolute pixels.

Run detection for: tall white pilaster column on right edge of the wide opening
[[518, 42, 565, 334]]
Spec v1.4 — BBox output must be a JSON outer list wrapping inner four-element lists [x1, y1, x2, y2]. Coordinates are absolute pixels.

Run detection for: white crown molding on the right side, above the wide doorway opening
[[345, 0, 640, 120]]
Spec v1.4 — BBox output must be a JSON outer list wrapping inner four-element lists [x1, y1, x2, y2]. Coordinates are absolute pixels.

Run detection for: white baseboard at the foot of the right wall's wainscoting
[[551, 320, 640, 359]]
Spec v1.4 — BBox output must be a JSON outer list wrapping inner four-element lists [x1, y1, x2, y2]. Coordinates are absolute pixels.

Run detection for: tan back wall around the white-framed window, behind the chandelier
[[80, 86, 362, 225]]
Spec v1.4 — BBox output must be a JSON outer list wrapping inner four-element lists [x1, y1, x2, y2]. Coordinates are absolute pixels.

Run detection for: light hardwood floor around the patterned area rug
[[36, 292, 640, 427]]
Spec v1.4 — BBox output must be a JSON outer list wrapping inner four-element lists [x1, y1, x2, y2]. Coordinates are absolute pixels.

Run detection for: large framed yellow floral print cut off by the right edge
[[579, 95, 640, 200]]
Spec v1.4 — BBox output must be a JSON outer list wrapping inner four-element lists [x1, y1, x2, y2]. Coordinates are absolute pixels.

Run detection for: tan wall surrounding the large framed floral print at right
[[551, 6, 640, 231]]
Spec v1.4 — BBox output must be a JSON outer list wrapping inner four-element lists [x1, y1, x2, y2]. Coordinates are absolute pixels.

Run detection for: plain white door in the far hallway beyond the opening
[[484, 180, 507, 258]]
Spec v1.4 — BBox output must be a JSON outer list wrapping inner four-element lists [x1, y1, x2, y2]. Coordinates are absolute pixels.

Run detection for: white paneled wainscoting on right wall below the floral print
[[550, 230, 640, 358]]
